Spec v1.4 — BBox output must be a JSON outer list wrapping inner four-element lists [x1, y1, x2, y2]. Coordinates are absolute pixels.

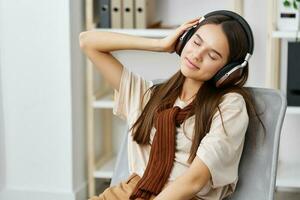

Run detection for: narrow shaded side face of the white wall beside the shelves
[[69, 0, 87, 200]]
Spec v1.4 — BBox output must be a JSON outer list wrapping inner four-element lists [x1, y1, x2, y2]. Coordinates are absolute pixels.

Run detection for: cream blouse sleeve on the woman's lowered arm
[[197, 93, 249, 188]]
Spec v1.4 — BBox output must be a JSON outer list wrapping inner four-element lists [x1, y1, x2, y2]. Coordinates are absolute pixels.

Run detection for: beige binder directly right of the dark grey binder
[[110, 0, 123, 28]]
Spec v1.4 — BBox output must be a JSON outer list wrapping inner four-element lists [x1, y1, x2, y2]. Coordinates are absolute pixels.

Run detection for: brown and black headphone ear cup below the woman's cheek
[[212, 62, 243, 87]]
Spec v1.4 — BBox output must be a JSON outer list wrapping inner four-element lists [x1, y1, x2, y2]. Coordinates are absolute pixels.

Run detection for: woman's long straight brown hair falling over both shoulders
[[130, 15, 265, 163]]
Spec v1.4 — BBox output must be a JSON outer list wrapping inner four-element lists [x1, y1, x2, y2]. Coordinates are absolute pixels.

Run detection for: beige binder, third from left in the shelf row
[[123, 0, 135, 28]]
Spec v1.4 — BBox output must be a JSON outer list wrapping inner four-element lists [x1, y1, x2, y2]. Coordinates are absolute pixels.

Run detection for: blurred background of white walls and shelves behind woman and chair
[[0, 0, 300, 200]]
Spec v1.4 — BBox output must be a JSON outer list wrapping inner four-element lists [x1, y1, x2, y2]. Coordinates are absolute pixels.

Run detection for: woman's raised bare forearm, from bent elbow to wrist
[[79, 31, 163, 52]]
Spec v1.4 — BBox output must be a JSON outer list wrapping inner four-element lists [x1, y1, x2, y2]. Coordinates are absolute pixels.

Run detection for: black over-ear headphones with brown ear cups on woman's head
[[175, 10, 254, 87]]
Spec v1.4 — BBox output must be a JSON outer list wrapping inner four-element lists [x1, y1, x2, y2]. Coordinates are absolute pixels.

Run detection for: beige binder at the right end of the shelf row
[[134, 0, 157, 29]]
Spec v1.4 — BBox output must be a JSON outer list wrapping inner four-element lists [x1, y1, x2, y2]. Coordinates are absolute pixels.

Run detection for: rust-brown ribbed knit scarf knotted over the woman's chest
[[129, 103, 193, 200]]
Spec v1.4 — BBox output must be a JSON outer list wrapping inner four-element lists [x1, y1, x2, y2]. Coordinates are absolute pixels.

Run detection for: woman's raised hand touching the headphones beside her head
[[159, 17, 201, 53]]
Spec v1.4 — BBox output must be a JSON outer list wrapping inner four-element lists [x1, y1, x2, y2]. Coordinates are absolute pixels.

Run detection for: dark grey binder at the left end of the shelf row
[[96, 0, 110, 28]]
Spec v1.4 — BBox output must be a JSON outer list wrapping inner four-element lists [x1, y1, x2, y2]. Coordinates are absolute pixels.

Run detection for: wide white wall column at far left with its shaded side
[[0, 0, 86, 200]]
